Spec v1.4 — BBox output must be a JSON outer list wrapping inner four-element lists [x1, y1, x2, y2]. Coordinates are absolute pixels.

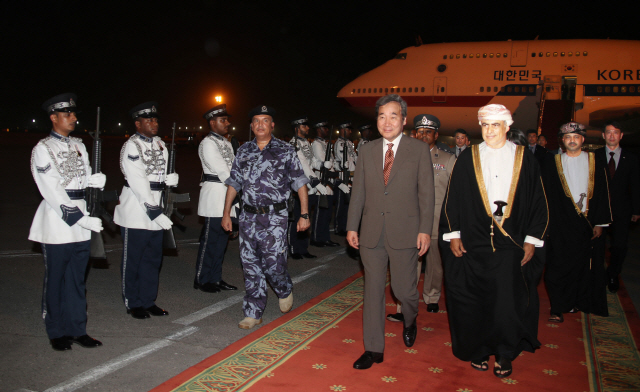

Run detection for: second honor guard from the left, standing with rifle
[[113, 102, 178, 319]]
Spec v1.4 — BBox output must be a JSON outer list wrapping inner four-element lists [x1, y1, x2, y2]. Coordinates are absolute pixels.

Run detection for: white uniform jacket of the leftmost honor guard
[[29, 131, 91, 244]]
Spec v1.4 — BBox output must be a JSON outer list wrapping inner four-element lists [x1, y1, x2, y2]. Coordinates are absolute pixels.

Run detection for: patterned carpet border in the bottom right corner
[[582, 293, 640, 392]]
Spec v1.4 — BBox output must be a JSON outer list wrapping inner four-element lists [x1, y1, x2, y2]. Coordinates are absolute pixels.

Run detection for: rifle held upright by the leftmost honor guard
[[86, 107, 118, 259]]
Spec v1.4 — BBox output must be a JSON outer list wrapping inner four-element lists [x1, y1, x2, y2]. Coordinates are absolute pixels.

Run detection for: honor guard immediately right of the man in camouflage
[[288, 117, 326, 260]]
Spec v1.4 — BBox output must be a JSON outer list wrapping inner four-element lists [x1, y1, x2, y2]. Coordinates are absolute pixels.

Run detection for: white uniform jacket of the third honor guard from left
[[198, 132, 235, 218]]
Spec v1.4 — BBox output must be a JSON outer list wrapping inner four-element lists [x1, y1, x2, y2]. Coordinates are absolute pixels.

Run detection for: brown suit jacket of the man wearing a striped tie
[[347, 135, 435, 249]]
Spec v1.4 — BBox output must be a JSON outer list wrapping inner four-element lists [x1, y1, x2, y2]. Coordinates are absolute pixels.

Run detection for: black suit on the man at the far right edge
[[595, 147, 640, 278]]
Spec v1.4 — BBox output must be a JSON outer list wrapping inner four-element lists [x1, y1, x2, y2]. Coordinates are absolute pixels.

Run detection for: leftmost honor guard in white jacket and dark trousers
[[29, 94, 106, 351]]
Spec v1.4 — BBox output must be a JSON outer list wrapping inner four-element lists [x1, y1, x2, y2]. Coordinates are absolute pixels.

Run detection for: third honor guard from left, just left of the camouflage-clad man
[[193, 104, 237, 293]]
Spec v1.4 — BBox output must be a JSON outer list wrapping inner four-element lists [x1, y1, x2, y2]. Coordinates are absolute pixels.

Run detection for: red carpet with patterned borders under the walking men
[[154, 274, 640, 392]]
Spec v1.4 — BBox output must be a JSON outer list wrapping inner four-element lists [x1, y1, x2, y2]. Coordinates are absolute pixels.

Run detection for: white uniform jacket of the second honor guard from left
[[113, 133, 169, 230]]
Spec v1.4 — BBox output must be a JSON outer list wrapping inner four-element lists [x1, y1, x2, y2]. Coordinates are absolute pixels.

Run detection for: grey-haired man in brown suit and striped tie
[[347, 94, 435, 369]]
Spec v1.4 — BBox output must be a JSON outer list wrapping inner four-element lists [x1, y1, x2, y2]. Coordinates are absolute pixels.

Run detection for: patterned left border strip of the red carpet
[[174, 277, 364, 392]]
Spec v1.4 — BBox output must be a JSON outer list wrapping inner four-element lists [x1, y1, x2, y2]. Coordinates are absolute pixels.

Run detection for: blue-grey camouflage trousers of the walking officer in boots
[[239, 210, 293, 319]]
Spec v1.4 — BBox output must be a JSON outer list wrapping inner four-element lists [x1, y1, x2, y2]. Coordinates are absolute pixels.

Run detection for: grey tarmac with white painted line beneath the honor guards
[[0, 134, 640, 392]]
